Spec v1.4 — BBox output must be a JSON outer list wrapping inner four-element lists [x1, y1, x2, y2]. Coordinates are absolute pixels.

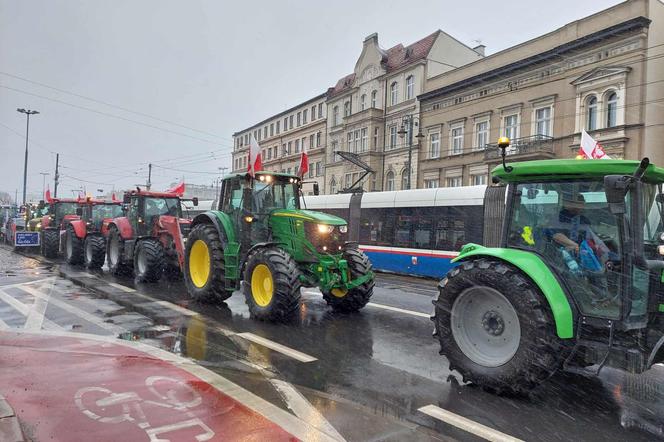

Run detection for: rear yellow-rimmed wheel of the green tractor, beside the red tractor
[[184, 224, 233, 302]]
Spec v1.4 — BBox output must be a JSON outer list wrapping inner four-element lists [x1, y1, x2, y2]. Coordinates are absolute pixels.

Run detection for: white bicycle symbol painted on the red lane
[[74, 376, 215, 442]]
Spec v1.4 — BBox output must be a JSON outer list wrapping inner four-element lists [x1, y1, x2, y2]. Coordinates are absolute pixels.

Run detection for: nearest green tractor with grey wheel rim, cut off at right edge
[[431, 139, 664, 394]]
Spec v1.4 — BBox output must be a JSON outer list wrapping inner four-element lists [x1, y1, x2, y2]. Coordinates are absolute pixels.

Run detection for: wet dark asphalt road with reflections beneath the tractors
[[0, 248, 664, 441]]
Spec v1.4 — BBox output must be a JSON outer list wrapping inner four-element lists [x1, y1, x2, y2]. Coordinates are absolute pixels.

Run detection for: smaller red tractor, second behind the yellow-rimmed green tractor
[[63, 197, 122, 269]]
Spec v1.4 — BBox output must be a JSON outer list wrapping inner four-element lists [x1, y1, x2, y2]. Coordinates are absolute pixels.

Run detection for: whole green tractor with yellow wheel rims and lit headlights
[[184, 172, 374, 321]]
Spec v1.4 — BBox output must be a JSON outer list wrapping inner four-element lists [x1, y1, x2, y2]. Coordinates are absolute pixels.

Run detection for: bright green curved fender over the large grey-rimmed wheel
[[452, 243, 574, 339]]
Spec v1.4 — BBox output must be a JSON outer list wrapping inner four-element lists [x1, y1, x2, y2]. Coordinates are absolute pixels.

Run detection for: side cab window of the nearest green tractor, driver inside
[[507, 181, 640, 319]]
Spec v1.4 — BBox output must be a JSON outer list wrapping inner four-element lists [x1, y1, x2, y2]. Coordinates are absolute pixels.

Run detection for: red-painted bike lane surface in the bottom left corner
[[0, 332, 298, 442]]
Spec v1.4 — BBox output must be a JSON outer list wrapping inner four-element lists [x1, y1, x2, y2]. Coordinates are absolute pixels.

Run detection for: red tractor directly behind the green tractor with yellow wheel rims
[[105, 188, 198, 282]]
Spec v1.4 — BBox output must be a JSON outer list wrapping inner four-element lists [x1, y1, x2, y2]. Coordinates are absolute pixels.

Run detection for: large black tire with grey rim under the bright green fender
[[431, 258, 569, 395]]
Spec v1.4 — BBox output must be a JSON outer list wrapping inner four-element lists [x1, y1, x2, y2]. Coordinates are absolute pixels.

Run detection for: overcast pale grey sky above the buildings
[[0, 0, 620, 199]]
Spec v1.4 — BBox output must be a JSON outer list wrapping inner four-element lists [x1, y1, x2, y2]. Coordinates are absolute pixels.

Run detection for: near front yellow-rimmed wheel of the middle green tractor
[[242, 247, 301, 322]]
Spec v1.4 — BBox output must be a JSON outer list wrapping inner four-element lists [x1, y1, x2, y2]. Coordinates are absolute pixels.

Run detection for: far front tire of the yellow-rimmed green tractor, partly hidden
[[323, 248, 374, 312]]
